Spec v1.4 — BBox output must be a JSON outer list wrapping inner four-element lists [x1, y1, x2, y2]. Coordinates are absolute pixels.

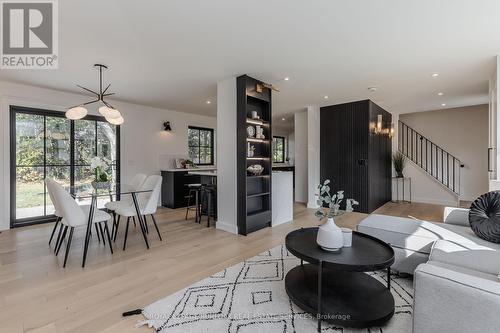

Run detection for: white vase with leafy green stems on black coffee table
[[314, 179, 359, 252]]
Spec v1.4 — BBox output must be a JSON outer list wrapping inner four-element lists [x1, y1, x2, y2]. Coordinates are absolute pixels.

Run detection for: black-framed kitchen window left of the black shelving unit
[[188, 126, 214, 165]]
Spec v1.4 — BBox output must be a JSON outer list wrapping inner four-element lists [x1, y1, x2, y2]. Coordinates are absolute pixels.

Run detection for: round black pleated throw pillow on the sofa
[[469, 191, 500, 243]]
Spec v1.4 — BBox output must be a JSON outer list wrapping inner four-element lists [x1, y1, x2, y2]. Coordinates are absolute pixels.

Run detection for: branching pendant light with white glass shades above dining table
[[66, 64, 124, 125]]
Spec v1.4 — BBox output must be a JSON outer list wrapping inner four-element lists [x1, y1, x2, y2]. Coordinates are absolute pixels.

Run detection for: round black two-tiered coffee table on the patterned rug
[[285, 228, 394, 331]]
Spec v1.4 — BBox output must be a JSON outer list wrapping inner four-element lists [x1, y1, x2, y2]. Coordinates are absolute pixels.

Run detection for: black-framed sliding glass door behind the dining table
[[10, 106, 120, 227]]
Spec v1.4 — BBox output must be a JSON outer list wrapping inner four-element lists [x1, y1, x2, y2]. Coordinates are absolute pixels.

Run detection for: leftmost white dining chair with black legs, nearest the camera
[[46, 180, 113, 267]]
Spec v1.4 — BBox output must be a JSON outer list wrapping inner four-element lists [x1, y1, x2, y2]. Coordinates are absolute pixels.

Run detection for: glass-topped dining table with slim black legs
[[69, 183, 153, 267]]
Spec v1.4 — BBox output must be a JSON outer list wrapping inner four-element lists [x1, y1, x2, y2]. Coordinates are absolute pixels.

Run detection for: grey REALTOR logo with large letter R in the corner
[[0, 0, 58, 69]]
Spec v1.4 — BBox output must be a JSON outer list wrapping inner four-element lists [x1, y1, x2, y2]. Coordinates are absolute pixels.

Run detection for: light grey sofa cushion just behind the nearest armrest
[[429, 240, 500, 274]]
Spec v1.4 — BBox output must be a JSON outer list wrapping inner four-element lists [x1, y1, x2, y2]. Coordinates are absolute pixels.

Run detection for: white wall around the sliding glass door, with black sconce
[[0, 81, 216, 230]]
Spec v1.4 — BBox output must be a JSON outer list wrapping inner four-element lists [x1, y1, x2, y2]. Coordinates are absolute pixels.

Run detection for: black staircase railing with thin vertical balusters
[[398, 120, 464, 199]]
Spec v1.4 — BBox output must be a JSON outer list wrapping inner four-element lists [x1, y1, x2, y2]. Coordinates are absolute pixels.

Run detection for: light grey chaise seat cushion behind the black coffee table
[[357, 214, 482, 254]]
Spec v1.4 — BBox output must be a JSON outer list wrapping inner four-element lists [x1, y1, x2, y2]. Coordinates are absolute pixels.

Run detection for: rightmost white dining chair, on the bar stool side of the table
[[116, 175, 162, 250]]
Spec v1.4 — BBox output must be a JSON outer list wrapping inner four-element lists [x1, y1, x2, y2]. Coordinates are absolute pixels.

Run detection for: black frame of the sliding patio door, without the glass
[[9, 105, 121, 228]]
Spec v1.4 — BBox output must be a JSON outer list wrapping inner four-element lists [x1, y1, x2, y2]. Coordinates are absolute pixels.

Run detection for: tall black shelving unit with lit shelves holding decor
[[236, 75, 273, 235]]
